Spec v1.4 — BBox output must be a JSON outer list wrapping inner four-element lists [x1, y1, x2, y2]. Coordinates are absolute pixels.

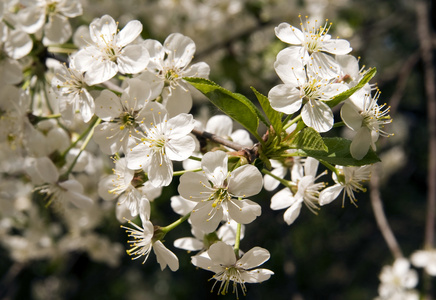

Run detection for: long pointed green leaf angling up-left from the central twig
[[183, 77, 265, 140]]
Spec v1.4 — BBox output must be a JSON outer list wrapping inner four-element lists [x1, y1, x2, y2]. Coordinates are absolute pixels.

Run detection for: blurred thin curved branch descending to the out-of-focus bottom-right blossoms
[[369, 164, 403, 258]]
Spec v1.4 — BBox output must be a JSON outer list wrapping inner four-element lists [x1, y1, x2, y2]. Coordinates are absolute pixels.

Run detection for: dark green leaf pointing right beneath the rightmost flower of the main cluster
[[297, 137, 380, 166]]
